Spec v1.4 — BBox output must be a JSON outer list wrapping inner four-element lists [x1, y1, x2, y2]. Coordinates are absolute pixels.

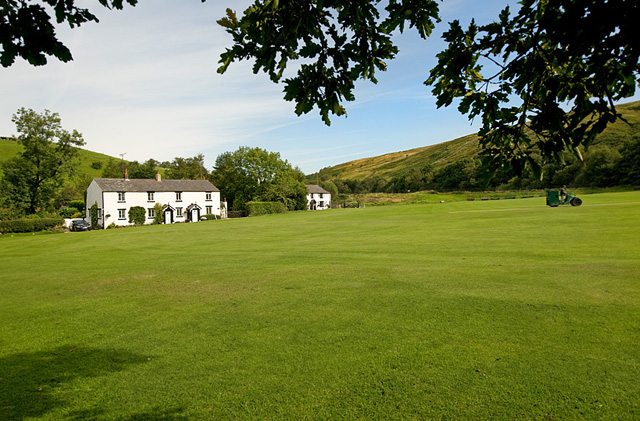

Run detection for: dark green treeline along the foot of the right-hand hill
[[316, 137, 640, 194]]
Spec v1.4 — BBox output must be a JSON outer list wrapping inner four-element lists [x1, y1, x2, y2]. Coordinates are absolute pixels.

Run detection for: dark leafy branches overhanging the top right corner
[[426, 0, 640, 173]]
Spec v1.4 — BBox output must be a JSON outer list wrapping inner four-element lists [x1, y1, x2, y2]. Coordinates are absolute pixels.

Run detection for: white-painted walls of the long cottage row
[[87, 188, 220, 227]]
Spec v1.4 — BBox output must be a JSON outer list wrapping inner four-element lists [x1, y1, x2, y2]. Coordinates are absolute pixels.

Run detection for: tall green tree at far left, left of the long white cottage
[[2, 108, 84, 214]]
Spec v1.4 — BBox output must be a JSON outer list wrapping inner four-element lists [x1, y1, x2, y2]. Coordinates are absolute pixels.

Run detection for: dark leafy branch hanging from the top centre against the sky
[[218, 0, 438, 125]]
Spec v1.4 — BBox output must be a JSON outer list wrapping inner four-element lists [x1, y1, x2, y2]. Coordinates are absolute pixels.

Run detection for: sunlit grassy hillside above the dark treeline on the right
[[322, 102, 640, 180]]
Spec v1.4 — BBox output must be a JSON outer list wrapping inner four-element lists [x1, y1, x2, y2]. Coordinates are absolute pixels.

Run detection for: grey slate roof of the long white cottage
[[93, 178, 220, 192]]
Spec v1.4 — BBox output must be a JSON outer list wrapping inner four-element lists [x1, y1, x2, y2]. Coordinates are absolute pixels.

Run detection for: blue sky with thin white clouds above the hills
[[0, 0, 636, 174]]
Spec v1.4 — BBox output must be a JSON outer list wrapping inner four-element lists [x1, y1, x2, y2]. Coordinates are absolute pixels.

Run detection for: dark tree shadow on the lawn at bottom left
[[0, 345, 179, 420]]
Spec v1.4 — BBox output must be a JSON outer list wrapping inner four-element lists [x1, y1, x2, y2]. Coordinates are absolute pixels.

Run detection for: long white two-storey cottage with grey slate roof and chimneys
[[86, 173, 220, 227]]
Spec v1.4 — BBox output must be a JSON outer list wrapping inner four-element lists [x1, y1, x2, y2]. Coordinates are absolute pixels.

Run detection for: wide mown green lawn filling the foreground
[[0, 192, 640, 420]]
